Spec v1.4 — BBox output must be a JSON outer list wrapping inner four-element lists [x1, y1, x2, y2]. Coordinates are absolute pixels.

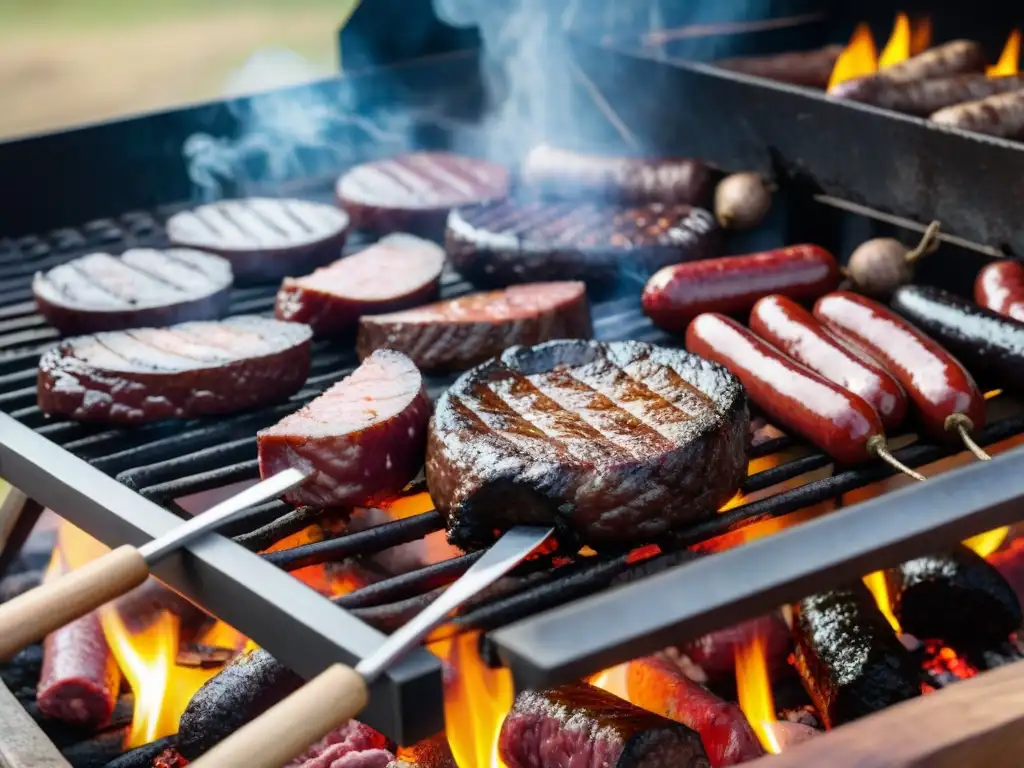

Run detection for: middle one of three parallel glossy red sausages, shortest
[[750, 295, 906, 430]]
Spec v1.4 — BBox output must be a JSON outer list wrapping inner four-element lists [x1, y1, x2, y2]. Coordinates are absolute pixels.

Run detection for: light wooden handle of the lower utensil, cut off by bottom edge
[[191, 664, 369, 768]]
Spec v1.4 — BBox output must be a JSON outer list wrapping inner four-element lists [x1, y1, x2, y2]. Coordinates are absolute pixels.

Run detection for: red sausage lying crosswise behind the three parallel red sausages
[[641, 245, 840, 332]]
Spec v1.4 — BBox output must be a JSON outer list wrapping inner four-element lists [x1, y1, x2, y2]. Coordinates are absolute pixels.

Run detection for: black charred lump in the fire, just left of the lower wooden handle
[[178, 648, 302, 760]]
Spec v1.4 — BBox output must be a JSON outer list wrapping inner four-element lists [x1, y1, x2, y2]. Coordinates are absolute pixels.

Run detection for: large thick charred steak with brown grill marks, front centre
[[426, 341, 750, 550]]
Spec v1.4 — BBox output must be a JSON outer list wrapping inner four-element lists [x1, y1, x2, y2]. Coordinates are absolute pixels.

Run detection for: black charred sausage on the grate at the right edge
[[892, 286, 1024, 387]]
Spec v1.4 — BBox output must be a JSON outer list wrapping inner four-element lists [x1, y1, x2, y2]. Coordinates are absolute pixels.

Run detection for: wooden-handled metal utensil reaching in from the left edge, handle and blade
[[0, 469, 306, 659]]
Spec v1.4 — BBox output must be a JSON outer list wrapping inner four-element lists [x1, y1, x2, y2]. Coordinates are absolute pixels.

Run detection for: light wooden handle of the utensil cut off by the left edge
[[0, 544, 150, 659]]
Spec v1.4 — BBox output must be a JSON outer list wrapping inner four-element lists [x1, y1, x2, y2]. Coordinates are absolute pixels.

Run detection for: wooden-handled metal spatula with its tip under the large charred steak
[[191, 525, 552, 768]]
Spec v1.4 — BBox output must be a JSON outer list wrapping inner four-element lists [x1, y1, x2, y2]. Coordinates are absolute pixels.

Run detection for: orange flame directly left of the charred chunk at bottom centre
[[429, 633, 515, 768]]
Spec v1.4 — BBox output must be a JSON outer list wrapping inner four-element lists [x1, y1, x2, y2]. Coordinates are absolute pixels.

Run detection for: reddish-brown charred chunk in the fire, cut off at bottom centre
[[498, 683, 711, 768]]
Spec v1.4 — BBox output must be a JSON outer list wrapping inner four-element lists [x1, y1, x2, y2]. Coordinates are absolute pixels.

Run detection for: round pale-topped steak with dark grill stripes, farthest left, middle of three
[[32, 248, 231, 334]]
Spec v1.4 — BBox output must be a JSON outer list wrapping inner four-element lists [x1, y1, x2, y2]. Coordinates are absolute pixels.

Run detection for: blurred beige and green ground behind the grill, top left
[[0, 0, 360, 138]]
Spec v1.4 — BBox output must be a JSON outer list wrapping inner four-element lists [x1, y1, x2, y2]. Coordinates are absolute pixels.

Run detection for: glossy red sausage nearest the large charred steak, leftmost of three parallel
[[686, 313, 883, 464]]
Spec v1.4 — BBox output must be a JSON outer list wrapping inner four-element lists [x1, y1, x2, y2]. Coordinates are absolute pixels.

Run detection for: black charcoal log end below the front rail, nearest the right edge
[[886, 545, 1022, 648]]
